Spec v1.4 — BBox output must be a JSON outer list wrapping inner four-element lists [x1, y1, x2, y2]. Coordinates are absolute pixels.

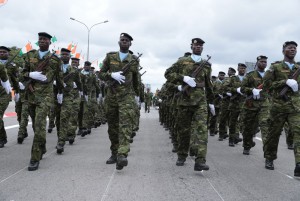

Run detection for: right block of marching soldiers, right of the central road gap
[[158, 38, 300, 177]]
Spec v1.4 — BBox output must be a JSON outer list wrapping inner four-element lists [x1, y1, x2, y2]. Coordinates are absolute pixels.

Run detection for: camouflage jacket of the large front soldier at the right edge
[[263, 61, 300, 113]]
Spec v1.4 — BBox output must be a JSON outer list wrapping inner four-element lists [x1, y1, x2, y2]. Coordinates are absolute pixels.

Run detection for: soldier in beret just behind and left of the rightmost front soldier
[[240, 55, 269, 155]]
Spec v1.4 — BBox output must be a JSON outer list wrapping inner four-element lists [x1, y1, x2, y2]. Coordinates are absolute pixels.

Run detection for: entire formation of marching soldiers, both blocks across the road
[[0, 32, 300, 177]]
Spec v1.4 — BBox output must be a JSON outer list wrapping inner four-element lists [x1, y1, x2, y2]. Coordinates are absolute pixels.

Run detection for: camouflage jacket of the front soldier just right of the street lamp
[[99, 52, 139, 98]]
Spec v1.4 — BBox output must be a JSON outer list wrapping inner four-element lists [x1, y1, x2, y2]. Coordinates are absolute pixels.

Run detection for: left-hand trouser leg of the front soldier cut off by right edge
[[264, 110, 288, 161]]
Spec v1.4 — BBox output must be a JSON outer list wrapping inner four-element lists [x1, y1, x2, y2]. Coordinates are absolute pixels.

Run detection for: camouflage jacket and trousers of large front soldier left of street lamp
[[22, 50, 63, 162]]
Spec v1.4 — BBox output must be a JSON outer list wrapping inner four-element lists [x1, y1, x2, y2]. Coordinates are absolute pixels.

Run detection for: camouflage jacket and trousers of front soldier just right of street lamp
[[99, 52, 139, 157]]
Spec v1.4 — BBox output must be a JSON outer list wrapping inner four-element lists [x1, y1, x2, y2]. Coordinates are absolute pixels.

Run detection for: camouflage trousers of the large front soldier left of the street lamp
[[28, 102, 50, 161]]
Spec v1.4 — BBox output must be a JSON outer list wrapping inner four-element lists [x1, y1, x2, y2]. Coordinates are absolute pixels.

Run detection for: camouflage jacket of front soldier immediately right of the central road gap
[[165, 56, 214, 106]]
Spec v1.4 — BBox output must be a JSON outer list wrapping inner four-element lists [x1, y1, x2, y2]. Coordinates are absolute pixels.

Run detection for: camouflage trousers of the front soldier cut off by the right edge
[[264, 109, 300, 163]]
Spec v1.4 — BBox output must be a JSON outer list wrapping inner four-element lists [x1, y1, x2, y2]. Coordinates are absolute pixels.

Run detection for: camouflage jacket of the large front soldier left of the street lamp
[[21, 50, 64, 106]]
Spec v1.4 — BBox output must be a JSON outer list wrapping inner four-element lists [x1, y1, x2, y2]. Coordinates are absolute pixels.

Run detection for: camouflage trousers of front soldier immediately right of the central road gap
[[177, 103, 208, 163]]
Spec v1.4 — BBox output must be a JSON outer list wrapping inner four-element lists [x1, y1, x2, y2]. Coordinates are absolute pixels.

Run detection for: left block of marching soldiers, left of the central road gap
[[0, 32, 144, 171]]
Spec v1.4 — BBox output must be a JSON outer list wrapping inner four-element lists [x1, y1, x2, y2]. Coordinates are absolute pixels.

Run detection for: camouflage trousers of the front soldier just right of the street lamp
[[105, 95, 136, 157]]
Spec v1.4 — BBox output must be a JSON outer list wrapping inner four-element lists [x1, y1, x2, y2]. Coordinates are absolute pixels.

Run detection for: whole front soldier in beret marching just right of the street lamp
[[100, 33, 139, 170]]
